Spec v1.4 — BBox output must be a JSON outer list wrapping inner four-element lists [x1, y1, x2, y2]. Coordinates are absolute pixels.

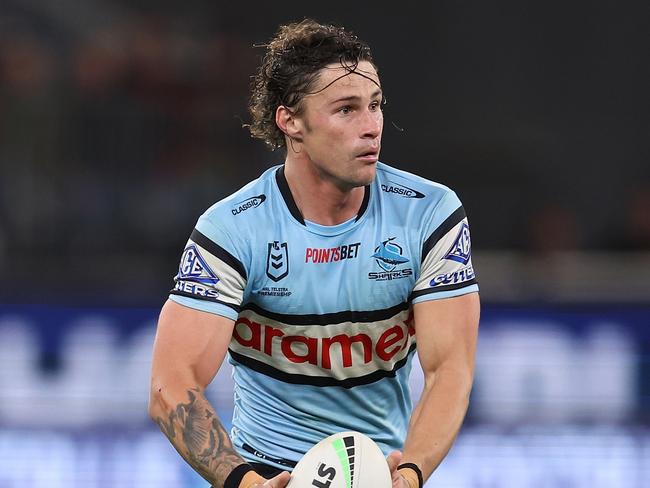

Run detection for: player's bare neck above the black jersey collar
[[284, 152, 365, 225]]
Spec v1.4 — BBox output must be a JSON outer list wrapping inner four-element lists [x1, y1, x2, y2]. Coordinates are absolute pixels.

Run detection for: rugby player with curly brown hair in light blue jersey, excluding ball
[[149, 19, 479, 488]]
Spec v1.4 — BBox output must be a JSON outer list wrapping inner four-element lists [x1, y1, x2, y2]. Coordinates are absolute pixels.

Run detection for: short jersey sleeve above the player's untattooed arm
[[411, 190, 478, 303]]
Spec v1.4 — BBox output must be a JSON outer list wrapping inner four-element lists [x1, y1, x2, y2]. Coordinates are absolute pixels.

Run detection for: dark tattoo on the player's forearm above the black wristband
[[156, 388, 244, 486]]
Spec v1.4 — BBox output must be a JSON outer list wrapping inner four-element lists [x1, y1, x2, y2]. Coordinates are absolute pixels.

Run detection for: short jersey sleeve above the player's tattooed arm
[[169, 216, 247, 320]]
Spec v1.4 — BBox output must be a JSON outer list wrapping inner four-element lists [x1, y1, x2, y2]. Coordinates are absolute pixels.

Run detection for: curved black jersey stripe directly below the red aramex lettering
[[228, 344, 415, 388]]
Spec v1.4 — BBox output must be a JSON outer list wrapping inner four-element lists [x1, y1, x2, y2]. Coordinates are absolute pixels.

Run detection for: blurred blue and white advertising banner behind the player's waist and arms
[[0, 305, 650, 488]]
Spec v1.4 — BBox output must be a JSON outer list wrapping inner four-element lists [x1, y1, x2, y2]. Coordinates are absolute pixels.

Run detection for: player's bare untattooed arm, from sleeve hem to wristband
[[402, 293, 480, 480]]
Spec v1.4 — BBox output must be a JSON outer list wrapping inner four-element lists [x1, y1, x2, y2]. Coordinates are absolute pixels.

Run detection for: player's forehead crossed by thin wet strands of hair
[[308, 61, 381, 98]]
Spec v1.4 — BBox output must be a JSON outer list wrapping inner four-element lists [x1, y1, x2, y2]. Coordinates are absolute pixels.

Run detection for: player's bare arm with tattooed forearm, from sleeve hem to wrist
[[149, 301, 245, 486]]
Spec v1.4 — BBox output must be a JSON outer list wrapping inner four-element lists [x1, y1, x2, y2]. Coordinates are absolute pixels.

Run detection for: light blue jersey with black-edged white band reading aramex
[[170, 163, 478, 468]]
